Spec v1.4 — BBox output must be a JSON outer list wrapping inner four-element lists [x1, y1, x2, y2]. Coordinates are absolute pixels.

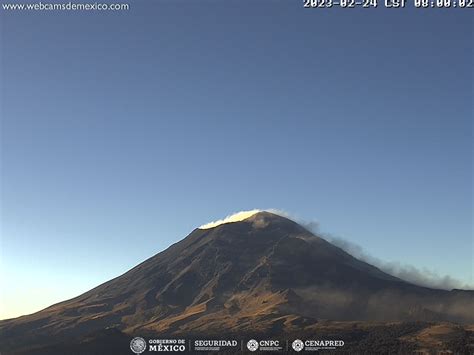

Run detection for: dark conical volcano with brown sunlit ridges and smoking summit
[[0, 212, 474, 350]]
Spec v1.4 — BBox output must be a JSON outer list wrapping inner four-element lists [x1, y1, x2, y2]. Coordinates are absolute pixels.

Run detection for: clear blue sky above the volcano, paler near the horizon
[[0, 0, 473, 317]]
